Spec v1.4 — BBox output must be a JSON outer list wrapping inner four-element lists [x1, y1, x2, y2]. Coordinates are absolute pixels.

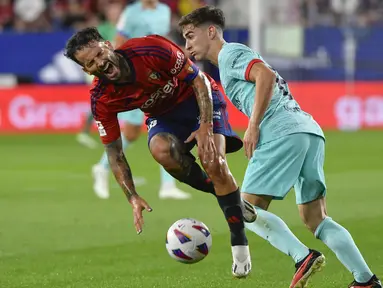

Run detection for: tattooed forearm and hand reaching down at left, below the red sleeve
[[105, 138, 152, 234]]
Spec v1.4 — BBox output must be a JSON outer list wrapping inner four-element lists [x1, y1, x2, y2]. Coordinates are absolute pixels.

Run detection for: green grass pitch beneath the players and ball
[[0, 131, 383, 288]]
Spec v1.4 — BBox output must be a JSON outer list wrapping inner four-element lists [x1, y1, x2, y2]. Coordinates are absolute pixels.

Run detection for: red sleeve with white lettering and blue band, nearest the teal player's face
[[149, 35, 199, 82]]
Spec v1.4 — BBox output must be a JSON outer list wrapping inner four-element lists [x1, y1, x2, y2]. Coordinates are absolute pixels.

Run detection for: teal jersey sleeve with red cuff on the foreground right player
[[219, 44, 263, 81]]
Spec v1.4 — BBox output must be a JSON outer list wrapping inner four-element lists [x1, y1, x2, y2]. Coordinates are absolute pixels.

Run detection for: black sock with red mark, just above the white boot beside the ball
[[217, 189, 248, 246]]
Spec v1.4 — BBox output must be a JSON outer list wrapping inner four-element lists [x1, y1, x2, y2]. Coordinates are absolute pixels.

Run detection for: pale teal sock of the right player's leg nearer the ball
[[245, 206, 310, 263]]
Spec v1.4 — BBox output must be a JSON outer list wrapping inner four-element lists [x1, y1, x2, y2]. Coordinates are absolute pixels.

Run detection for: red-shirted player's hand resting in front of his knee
[[185, 124, 217, 164]]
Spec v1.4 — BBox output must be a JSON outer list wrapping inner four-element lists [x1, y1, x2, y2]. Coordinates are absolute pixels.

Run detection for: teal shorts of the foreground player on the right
[[241, 133, 326, 204]]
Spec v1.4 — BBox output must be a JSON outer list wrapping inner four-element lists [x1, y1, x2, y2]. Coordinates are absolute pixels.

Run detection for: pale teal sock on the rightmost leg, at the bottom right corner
[[315, 217, 373, 283]]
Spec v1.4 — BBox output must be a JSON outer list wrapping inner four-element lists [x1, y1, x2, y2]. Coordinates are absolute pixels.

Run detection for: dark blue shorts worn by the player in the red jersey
[[146, 91, 243, 153]]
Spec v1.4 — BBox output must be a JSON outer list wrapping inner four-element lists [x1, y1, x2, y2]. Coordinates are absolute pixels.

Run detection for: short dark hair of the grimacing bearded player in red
[[64, 27, 104, 65]]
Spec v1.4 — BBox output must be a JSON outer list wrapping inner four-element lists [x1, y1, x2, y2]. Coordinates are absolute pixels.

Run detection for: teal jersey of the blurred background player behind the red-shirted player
[[117, 1, 171, 38]]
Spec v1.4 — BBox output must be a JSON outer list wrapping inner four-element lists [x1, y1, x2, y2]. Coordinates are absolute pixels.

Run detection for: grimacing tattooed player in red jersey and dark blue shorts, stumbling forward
[[65, 28, 255, 277]]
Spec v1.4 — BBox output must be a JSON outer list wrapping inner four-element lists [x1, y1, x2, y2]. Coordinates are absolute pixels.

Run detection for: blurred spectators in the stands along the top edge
[[0, 0, 383, 33]]
